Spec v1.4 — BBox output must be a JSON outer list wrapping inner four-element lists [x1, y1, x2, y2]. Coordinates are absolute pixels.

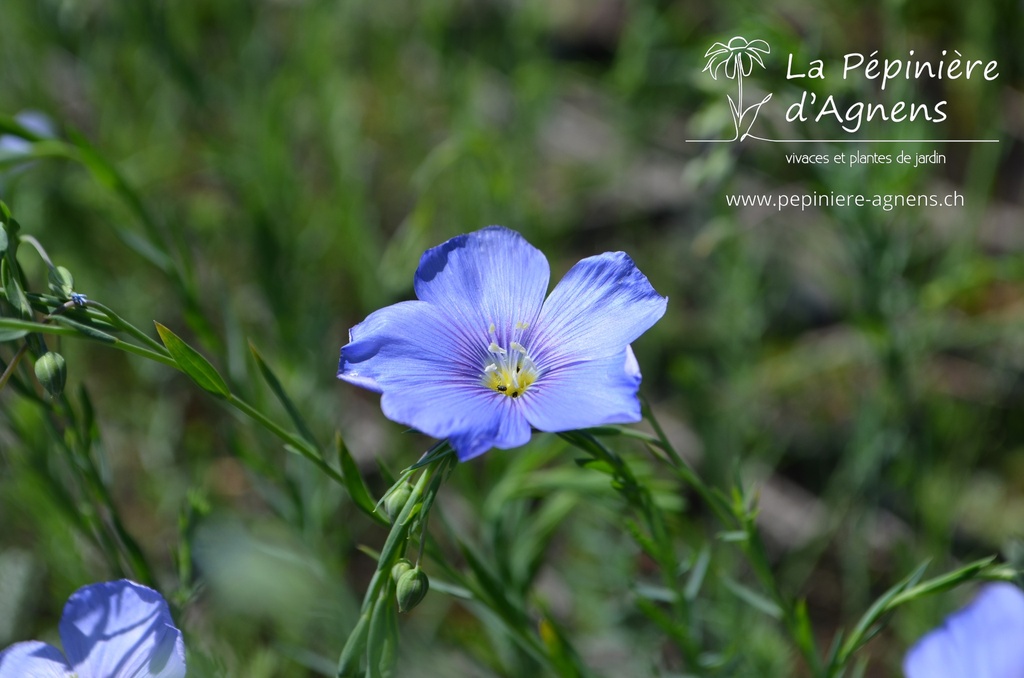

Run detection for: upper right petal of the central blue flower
[[530, 252, 669, 368]]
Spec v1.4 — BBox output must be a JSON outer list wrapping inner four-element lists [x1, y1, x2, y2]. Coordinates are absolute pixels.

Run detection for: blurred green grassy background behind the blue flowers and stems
[[0, 0, 1024, 677]]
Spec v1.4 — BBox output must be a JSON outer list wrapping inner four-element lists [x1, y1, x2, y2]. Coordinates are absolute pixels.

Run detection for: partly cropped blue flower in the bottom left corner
[[0, 580, 185, 678]]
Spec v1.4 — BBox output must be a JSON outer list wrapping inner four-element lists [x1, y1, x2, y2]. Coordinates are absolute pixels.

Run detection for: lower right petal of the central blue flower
[[520, 346, 640, 432]]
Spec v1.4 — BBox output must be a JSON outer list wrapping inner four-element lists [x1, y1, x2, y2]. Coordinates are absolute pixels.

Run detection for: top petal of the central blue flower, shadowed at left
[[415, 226, 551, 345]]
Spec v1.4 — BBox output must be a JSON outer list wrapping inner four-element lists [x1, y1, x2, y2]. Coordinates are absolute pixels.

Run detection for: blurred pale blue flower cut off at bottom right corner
[[903, 583, 1024, 678]]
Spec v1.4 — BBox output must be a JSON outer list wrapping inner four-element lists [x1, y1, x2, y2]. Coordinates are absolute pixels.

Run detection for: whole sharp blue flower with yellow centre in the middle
[[338, 226, 668, 461]]
